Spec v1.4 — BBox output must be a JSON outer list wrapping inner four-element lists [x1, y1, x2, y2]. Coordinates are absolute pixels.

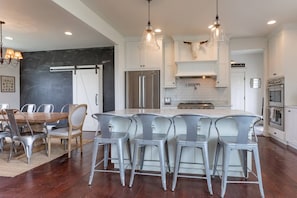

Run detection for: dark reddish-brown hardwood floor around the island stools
[[0, 137, 297, 198]]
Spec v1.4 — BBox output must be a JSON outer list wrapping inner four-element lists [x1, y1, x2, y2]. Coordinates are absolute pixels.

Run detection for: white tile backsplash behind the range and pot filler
[[164, 78, 230, 106]]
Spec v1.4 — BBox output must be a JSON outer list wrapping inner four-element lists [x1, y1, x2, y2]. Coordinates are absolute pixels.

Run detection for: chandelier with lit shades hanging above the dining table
[[0, 21, 23, 65]]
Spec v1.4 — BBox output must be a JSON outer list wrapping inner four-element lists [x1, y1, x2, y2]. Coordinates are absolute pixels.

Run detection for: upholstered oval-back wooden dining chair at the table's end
[[47, 104, 87, 158]]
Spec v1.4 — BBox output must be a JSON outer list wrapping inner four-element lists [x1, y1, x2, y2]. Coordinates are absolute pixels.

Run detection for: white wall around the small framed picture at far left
[[0, 64, 20, 108]]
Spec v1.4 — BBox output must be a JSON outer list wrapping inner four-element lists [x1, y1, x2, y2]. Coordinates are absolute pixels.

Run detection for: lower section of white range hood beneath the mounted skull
[[175, 60, 217, 77]]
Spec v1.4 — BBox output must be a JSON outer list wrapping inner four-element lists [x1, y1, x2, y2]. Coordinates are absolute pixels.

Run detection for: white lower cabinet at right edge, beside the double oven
[[285, 107, 297, 149]]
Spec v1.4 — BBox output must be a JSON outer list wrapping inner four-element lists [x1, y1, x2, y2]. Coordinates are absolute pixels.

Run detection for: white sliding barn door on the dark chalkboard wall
[[73, 65, 103, 131]]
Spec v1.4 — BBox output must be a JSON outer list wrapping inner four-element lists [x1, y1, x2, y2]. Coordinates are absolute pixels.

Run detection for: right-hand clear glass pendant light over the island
[[209, 0, 225, 41]]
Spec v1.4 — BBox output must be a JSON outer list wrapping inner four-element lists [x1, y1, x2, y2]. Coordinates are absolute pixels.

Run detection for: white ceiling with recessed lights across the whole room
[[0, 0, 297, 51]]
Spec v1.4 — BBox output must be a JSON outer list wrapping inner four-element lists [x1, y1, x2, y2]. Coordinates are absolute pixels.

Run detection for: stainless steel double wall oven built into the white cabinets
[[267, 77, 285, 131]]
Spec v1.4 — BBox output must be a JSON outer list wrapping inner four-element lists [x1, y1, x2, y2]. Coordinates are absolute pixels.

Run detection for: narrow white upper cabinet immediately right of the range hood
[[216, 41, 230, 87]]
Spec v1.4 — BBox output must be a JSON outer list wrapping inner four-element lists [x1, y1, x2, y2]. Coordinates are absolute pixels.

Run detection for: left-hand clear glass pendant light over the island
[[141, 0, 160, 50]]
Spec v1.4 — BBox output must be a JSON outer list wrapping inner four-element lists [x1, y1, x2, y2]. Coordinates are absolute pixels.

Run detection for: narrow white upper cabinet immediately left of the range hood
[[164, 39, 176, 88]]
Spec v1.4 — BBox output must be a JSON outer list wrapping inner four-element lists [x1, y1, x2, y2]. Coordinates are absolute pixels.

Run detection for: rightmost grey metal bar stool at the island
[[213, 115, 264, 197]]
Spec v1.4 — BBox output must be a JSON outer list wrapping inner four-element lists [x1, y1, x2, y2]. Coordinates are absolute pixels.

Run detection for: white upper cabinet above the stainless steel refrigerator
[[126, 39, 163, 70]]
